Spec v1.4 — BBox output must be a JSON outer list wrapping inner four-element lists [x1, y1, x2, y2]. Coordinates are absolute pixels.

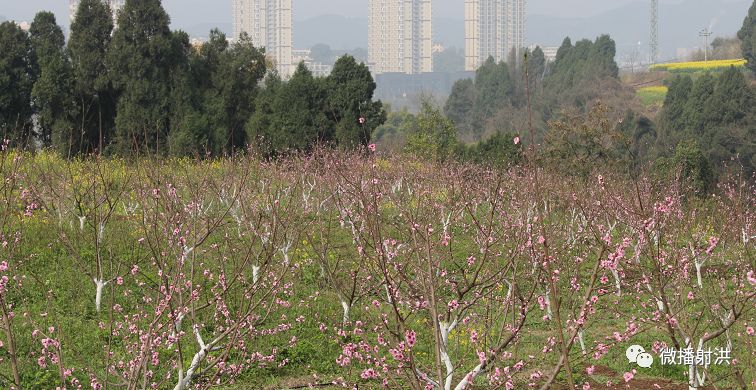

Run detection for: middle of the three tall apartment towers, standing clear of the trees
[[368, 0, 433, 74]]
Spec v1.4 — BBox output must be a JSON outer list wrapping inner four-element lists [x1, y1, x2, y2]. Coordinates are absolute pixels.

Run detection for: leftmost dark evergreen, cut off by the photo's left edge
[[0, 22, 36, 147]]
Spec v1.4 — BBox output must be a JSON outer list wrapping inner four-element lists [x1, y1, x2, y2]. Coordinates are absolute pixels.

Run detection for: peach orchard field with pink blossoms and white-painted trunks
[[0, 150, 756, 389]]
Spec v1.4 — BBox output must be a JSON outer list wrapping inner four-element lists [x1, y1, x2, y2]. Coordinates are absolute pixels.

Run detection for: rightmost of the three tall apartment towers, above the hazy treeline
[[465, 0, 526, 71]]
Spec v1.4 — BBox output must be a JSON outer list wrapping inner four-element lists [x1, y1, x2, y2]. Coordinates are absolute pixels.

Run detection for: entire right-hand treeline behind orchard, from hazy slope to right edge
[[375, 27, 756, 190]]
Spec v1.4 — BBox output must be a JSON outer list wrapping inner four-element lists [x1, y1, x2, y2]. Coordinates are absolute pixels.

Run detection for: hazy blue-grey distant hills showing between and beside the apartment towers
[[294, 0, 751, 59]]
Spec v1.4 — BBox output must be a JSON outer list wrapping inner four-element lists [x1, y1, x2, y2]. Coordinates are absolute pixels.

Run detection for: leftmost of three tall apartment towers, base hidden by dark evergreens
[[232, 0, 296, 77]]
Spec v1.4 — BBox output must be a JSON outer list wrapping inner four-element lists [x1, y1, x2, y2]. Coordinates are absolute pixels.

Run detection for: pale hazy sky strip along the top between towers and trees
[[0, 0, 692, 28]]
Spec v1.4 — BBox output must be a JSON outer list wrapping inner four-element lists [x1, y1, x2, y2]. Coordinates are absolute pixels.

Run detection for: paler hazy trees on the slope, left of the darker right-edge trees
[[375, 35, 632, 169]]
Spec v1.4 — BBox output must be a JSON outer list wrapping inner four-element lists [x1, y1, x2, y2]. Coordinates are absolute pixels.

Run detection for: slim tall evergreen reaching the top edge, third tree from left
[[67, 0, 115, 156]]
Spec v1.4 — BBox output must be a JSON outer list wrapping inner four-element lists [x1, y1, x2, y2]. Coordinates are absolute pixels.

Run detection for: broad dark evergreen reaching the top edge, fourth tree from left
[[107, 0, 176, 154]]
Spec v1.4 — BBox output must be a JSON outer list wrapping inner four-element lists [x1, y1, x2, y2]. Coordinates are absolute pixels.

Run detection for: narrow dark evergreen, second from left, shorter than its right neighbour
[[29, 12, 73, 146]]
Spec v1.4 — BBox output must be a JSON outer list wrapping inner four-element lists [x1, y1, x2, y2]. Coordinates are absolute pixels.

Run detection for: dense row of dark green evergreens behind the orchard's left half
[[0, 0, 384, 156]]
